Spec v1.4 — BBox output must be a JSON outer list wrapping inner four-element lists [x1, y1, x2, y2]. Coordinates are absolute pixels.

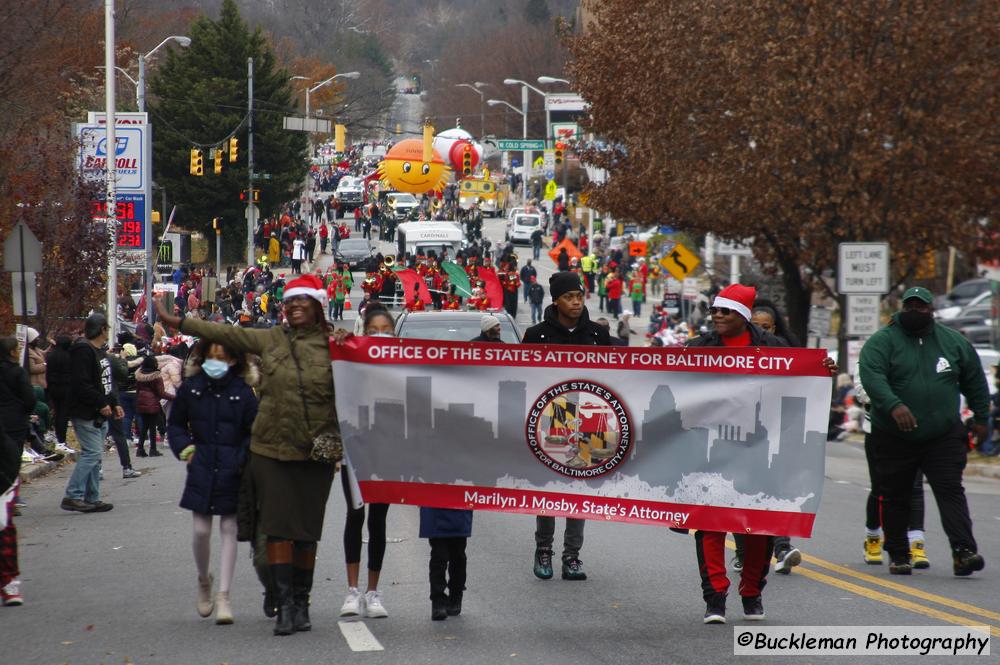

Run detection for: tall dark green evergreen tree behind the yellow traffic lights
[[148, 0, 308, 258]]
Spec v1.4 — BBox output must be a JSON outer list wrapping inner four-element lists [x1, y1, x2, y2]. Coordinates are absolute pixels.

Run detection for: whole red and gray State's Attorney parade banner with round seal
[[331, 337, 830, 537]]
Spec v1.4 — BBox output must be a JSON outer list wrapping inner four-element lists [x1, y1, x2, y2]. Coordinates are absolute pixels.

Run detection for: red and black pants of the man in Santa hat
[[694, 531, 774, 601]]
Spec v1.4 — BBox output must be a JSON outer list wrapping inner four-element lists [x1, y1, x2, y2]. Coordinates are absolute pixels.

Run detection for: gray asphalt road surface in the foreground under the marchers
[[7, 428, 1000, 665]]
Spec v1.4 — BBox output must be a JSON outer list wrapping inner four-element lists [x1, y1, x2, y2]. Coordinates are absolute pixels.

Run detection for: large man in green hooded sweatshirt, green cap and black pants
[[858, 286, 989, 576]]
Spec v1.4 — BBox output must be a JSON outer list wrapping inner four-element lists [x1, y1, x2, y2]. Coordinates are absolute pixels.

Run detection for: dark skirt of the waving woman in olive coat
[[249, 453, 337, 542]]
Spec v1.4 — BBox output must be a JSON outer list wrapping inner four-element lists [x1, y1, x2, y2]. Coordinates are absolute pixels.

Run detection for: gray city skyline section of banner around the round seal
[[338, 368, 826, 511]]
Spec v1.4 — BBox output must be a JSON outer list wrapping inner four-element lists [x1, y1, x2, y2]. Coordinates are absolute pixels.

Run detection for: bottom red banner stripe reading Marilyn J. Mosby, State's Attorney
[[358, 480, 816, 538]]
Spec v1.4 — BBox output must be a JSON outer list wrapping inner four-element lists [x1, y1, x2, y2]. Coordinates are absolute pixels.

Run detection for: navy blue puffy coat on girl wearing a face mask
[[167, 371, 257, 515]]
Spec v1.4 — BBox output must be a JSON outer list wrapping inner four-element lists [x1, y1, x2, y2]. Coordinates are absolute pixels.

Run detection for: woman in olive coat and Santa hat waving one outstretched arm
[[157, 275, 340, 635]]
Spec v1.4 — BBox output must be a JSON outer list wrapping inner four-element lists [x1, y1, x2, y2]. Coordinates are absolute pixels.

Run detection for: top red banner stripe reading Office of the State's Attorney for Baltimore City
[[330, 337, 830, 377]]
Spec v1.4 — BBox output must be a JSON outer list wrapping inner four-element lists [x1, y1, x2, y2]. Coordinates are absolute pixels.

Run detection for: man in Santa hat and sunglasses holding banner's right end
[[687, 284, 837, 624]]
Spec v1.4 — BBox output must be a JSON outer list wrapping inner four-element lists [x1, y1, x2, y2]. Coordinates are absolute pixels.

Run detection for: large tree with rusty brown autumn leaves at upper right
[[567, 0, 1000, 338]]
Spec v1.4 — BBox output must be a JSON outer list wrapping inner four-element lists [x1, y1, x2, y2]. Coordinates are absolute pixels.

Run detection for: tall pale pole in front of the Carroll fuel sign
[[104, 0, 118, 344]]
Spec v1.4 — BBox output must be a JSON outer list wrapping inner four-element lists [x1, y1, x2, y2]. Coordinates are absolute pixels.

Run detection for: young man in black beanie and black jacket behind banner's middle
[[521, 271, 611, 580]]
